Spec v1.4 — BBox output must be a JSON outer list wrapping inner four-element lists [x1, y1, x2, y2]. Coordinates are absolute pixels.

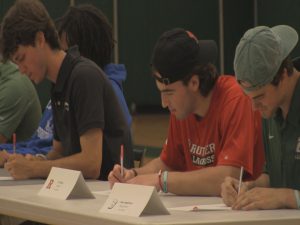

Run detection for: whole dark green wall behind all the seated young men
[[0, 0, 300, 108]]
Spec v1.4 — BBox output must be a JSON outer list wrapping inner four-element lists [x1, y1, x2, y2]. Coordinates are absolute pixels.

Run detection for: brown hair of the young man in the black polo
[[0, 0, 60, 60]]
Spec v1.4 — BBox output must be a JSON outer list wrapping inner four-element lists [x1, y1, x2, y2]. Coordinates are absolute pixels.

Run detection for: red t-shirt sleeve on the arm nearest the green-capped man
[[217, 96, 264, 177]]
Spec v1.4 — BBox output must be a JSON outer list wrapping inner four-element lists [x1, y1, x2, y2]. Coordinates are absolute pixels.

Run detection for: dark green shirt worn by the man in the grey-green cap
[[263, 80, 300, 190]]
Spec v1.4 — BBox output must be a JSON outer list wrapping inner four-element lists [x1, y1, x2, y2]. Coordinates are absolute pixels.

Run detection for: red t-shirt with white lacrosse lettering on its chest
[[160, 76, 265, 179]]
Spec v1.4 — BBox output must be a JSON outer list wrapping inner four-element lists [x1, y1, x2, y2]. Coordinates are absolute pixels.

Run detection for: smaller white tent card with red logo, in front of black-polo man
[[38, 167, 95, 200]]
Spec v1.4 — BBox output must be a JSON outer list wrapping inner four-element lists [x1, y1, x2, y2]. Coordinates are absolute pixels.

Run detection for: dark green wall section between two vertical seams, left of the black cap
[[119, 0, 219, 109]]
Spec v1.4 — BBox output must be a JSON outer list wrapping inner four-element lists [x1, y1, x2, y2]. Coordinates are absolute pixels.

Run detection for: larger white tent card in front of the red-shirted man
[[100, 183, 169, 217]]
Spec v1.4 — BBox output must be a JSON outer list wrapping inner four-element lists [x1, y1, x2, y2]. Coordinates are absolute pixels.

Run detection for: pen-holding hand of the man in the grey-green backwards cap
[[221, 177, 250, 206]]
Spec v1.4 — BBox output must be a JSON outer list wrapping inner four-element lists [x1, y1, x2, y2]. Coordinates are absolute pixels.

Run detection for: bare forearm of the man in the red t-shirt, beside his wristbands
[[167, 166, 240, 196]]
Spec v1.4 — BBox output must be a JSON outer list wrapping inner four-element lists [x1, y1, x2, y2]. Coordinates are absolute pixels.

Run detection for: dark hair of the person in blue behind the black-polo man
[[56, 5, 114, 68]]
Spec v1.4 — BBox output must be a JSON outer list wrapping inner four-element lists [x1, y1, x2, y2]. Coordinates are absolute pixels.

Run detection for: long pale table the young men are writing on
[[0, 169, 300, 225]]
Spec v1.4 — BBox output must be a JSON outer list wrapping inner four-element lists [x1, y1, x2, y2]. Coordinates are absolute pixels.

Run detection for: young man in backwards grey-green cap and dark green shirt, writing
[[222, 25, 300, 210]]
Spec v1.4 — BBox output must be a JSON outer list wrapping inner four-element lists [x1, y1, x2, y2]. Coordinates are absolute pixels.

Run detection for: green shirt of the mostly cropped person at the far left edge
[[0, 62, 41, 141]]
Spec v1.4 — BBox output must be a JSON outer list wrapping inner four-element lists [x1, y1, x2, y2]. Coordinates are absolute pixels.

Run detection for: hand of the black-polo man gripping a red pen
[[4, 154, 34, 180]]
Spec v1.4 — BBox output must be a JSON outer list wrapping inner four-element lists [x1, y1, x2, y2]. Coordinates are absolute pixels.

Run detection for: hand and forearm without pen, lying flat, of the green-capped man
[[232, 187, 296, 210]]
